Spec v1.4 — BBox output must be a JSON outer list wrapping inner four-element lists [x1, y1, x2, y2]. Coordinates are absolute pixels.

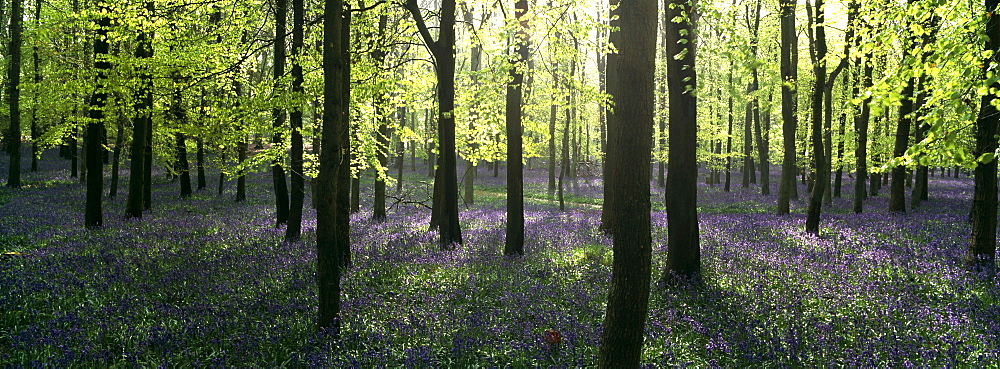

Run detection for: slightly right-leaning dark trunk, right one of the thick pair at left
[[125, 7, 153, 218]]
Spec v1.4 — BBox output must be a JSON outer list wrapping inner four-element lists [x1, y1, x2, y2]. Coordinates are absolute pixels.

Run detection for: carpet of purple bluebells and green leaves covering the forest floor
[[0, 152, 1000, 367]]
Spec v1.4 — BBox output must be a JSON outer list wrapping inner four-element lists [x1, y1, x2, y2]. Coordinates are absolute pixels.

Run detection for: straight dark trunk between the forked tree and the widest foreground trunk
[[503, 0, 528, 256]]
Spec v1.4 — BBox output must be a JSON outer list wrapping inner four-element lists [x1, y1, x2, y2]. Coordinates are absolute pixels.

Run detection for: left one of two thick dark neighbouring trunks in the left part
[[84, 1, 111, 228]]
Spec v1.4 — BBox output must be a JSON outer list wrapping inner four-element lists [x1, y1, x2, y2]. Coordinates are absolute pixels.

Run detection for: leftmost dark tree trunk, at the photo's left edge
[[7, 0, 23, 188]]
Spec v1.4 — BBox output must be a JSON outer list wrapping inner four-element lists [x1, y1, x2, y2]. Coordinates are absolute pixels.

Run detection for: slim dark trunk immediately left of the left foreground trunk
[[285, 0, 306, 241]]
